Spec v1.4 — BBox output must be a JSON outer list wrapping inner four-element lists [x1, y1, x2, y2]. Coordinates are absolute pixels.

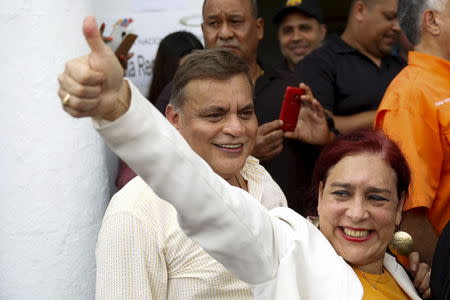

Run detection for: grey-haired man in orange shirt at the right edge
[[375, 0, 450, 263]]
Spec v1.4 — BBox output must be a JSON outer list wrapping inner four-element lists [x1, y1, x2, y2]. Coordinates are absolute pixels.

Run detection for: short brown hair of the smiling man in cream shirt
[[169, 48, 253, 109]]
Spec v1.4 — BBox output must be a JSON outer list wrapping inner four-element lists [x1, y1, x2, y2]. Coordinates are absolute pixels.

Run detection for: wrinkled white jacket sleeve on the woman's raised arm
[[94, 83, 278, 284]]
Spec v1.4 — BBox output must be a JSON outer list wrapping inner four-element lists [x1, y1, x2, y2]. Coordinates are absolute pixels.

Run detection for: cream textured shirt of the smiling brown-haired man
[[96, 157, 286, 300]]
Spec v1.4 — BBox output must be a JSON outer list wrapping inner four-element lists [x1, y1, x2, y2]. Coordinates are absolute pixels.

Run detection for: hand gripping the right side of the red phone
[[284, 83, 332, 145]]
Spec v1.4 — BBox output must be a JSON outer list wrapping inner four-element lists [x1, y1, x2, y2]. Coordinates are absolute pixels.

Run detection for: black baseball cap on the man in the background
[[273, 0, 323, 25]]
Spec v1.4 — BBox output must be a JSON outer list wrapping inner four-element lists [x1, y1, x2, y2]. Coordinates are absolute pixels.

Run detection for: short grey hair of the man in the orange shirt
[[398, 0, 448, 46]]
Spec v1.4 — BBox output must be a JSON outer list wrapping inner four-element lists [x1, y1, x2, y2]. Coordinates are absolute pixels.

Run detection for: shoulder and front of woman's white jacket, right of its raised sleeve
[[261, 207, 363, 300]]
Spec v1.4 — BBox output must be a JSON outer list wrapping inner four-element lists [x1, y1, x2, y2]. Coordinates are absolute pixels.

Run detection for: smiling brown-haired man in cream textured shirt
[[96, 45, 287, 299]]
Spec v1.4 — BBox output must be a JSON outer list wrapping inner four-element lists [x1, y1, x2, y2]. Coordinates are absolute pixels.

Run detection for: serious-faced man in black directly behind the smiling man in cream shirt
[[156, 0, 332, 216]]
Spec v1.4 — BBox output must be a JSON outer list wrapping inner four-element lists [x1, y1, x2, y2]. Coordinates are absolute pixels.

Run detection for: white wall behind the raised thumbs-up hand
[[0, 0, 202, 300]]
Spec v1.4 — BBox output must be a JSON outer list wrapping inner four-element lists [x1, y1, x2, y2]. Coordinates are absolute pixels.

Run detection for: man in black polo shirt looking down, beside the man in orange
[[296, 0, 405, 132]]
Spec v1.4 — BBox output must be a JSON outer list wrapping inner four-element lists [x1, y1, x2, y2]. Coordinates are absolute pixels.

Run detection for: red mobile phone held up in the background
[[280, 86, 305, 131]]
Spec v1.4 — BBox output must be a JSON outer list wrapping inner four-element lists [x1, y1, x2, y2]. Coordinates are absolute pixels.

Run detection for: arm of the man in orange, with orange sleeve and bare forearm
[[375, 87, 443, 266]]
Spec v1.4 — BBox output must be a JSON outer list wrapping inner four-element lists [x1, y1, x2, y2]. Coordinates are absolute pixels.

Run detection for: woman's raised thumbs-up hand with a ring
[[58, 17, 130, 121]]
